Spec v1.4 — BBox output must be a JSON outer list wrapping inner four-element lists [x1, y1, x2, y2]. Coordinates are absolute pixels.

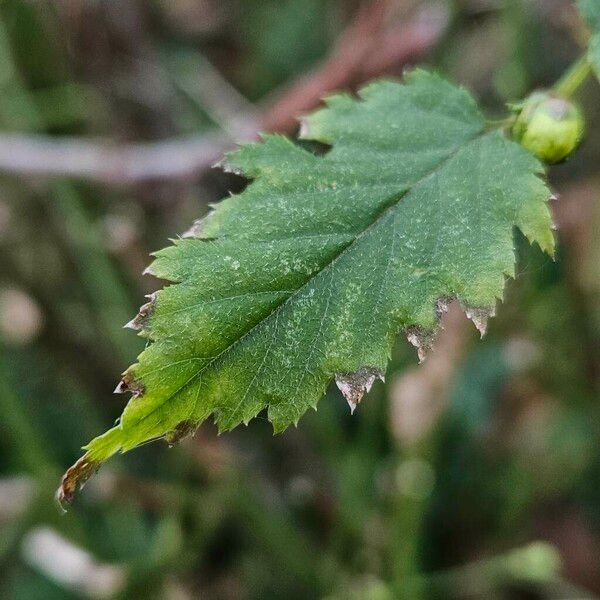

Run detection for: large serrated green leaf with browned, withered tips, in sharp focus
[[61, 71, 554, 499]]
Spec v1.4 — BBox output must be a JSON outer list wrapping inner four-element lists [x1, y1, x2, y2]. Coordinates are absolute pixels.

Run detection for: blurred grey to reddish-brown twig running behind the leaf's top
[[0, 0, 449, 184]]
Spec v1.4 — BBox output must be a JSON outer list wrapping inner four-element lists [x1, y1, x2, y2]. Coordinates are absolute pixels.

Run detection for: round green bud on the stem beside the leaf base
[[512, 92, 584, 164]]
